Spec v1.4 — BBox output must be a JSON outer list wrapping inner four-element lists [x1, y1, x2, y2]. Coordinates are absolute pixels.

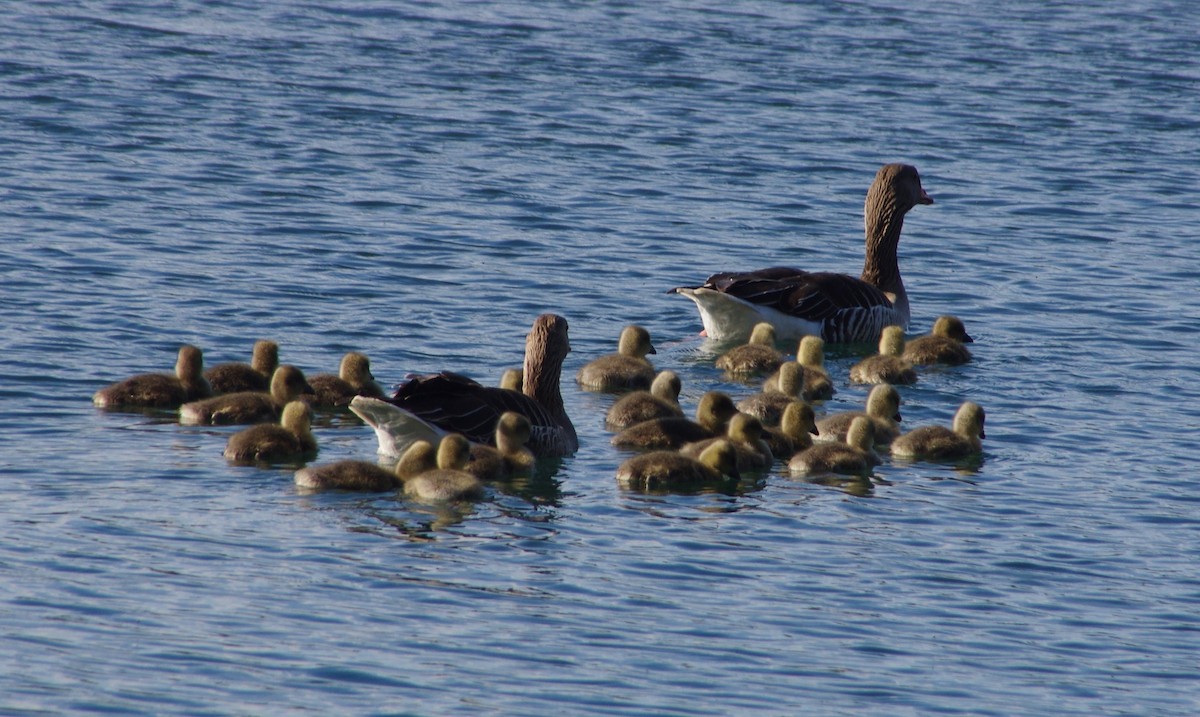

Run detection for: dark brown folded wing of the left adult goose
[[388, 370, 559, 444]]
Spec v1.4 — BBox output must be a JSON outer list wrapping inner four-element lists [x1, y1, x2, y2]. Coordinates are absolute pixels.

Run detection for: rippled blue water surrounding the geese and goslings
[[0, 0, 1200, 715]]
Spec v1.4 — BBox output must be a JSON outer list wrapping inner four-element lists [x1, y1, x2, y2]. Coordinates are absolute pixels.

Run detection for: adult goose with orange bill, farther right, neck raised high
[[671, 164, 934, 343]]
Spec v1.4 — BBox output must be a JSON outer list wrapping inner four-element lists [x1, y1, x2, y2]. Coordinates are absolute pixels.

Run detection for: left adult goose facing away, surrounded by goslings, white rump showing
[[350, 314, 580, 456]]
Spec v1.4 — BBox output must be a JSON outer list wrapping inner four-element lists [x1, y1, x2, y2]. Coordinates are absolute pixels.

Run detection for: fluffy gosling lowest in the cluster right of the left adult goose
[[617, 439, 742, 490]]
